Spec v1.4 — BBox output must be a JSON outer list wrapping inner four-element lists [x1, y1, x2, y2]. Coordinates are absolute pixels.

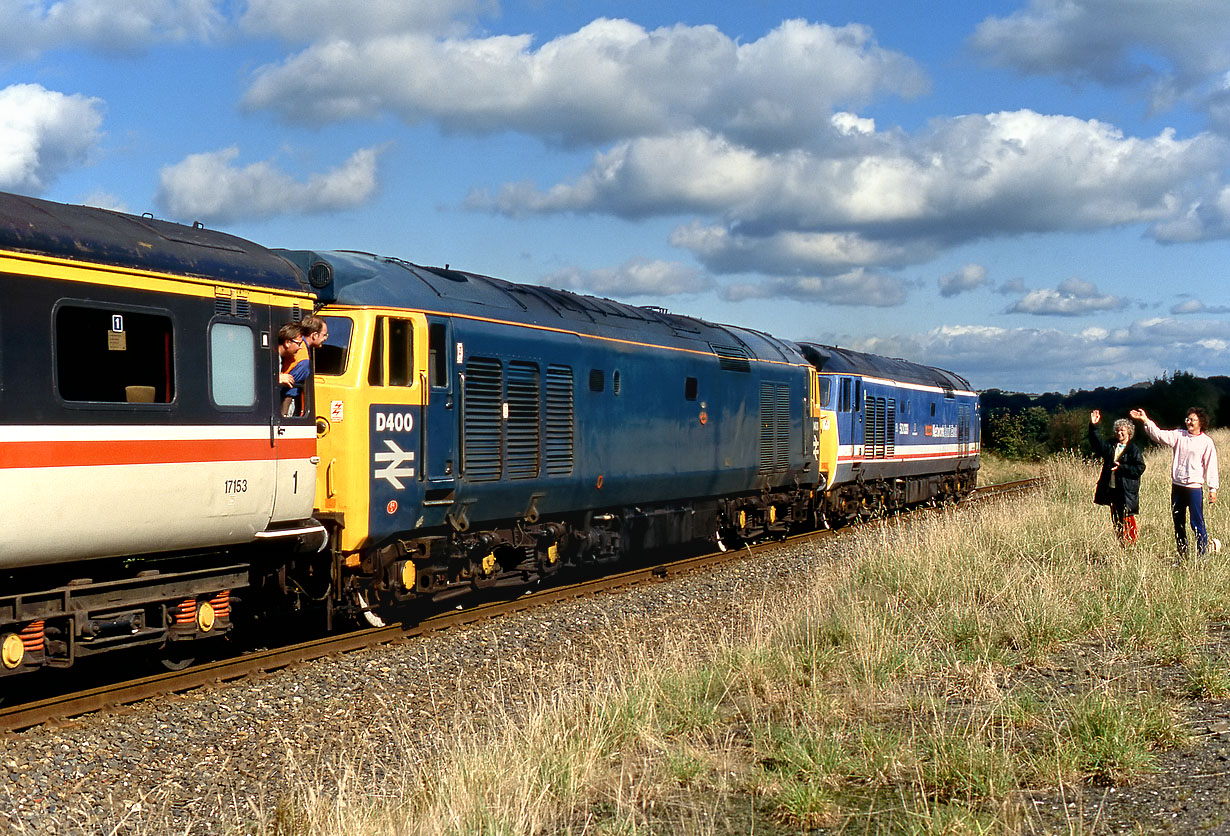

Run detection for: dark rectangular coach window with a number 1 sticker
[[55, 305, 175, 403]]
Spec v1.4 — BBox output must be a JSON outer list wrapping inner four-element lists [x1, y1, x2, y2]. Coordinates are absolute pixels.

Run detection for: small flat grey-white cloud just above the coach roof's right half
[[155, 146, 380, 223]]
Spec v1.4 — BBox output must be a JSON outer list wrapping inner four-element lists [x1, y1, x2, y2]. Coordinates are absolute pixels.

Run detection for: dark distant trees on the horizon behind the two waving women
[[980, 370, 1230, 459]]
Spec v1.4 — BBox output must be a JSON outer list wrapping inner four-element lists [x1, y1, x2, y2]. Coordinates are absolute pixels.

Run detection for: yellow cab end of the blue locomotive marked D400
[[315, 309, 427, 552]]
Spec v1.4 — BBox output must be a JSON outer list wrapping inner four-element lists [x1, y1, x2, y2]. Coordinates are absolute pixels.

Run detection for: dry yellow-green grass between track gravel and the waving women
[[269, 435, 1230, 834]]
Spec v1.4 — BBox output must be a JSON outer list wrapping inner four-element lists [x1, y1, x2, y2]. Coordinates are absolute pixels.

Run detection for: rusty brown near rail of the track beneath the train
[[0, 478, 1042, 732]]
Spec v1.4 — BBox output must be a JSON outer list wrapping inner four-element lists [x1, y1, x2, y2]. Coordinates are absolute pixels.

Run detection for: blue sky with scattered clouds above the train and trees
[[0, 0, 1230, 391]]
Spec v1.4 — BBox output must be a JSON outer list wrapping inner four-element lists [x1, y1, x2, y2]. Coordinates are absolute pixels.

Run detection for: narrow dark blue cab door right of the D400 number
[[419, 316, 465, 505]]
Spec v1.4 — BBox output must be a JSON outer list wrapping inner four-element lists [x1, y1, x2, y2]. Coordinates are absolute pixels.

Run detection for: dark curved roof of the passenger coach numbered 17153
[[0, 192, 308, 291]]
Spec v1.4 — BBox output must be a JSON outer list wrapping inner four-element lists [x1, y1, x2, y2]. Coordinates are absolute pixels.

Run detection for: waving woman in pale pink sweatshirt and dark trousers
[[1128, 407, 1218, 557]]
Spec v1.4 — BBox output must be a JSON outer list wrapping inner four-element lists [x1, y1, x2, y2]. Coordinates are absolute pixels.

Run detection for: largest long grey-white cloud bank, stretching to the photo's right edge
[[467, 111, 1230, 274]]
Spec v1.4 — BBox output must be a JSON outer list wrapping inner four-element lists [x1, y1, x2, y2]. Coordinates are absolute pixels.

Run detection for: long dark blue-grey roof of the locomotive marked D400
[[278, 251, 803, 366]]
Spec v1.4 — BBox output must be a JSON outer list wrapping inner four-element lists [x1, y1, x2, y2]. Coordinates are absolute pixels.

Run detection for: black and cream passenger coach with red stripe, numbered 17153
[[0, 194, 322, 674]]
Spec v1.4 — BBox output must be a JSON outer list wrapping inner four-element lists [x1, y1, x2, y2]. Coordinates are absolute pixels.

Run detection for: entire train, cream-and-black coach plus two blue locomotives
[[0, 195, 979, 674]]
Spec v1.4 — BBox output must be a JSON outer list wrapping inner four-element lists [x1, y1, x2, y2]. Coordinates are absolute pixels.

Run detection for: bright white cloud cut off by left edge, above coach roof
[[0, 84, 103, 194]]
